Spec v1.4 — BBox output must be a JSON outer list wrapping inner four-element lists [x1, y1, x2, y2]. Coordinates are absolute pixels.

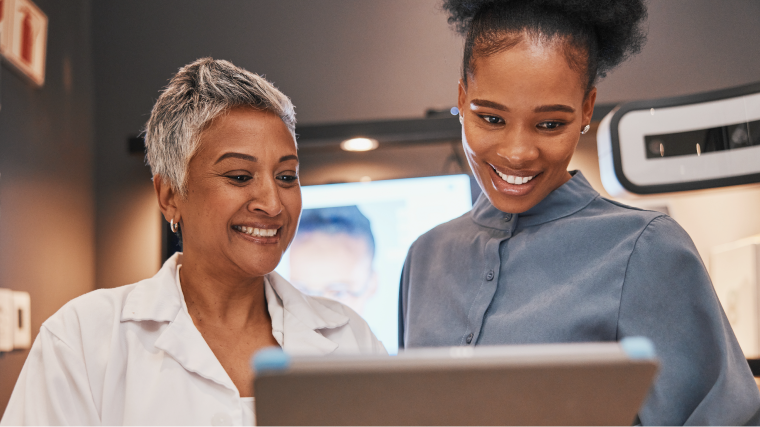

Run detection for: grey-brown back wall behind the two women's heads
[[93, 0, 760, 287]]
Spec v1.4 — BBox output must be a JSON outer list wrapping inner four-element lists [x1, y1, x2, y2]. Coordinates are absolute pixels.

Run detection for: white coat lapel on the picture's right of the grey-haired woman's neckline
[[264, 272, 349, 355]]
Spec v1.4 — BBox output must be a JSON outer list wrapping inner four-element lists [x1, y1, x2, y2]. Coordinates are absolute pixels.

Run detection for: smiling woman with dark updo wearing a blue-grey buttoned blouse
[[399, 0, 760, 426]]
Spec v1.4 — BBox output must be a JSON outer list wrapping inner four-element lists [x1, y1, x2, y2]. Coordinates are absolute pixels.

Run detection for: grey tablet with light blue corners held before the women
[[253, 338, 657, 427]]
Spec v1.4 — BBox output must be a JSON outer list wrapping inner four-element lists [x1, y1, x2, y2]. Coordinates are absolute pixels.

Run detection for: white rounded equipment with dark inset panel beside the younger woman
[[597, 83, 760, 196]]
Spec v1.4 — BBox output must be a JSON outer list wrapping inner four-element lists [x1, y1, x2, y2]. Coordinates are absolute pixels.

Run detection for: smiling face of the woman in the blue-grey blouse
[[459, 35, 596, 213]]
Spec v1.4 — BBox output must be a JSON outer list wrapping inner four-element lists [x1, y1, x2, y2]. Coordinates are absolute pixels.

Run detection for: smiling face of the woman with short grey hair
[[175, 108, 301, 277]]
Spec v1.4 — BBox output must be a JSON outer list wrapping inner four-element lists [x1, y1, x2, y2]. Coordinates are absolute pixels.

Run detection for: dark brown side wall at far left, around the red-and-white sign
[[0, 0, 95, 414]]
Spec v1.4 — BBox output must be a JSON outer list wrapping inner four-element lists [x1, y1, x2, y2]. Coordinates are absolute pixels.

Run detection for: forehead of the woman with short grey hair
[[197, 107, 296, 158]]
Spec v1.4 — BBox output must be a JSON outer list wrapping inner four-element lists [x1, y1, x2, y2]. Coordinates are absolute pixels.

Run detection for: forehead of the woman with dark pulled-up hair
[[467, 37, 585, 108]]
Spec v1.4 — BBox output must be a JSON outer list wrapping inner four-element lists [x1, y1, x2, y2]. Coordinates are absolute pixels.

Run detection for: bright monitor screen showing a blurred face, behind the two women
[[276, 175, 472, 354]]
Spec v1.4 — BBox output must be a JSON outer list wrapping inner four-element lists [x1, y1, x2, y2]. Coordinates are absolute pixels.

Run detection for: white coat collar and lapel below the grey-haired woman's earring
[[121, 254, 237, 392]]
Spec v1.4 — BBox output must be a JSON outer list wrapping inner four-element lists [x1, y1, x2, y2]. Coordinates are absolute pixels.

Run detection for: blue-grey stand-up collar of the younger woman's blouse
[[472, 171, 599, 232]]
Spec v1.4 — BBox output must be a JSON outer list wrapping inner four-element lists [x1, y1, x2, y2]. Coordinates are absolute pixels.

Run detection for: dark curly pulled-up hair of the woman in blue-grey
[[443, 0, 647, 93]]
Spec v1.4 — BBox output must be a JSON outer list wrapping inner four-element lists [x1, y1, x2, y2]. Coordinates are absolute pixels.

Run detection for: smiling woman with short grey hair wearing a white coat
[[0, 58, 385, 427]]
